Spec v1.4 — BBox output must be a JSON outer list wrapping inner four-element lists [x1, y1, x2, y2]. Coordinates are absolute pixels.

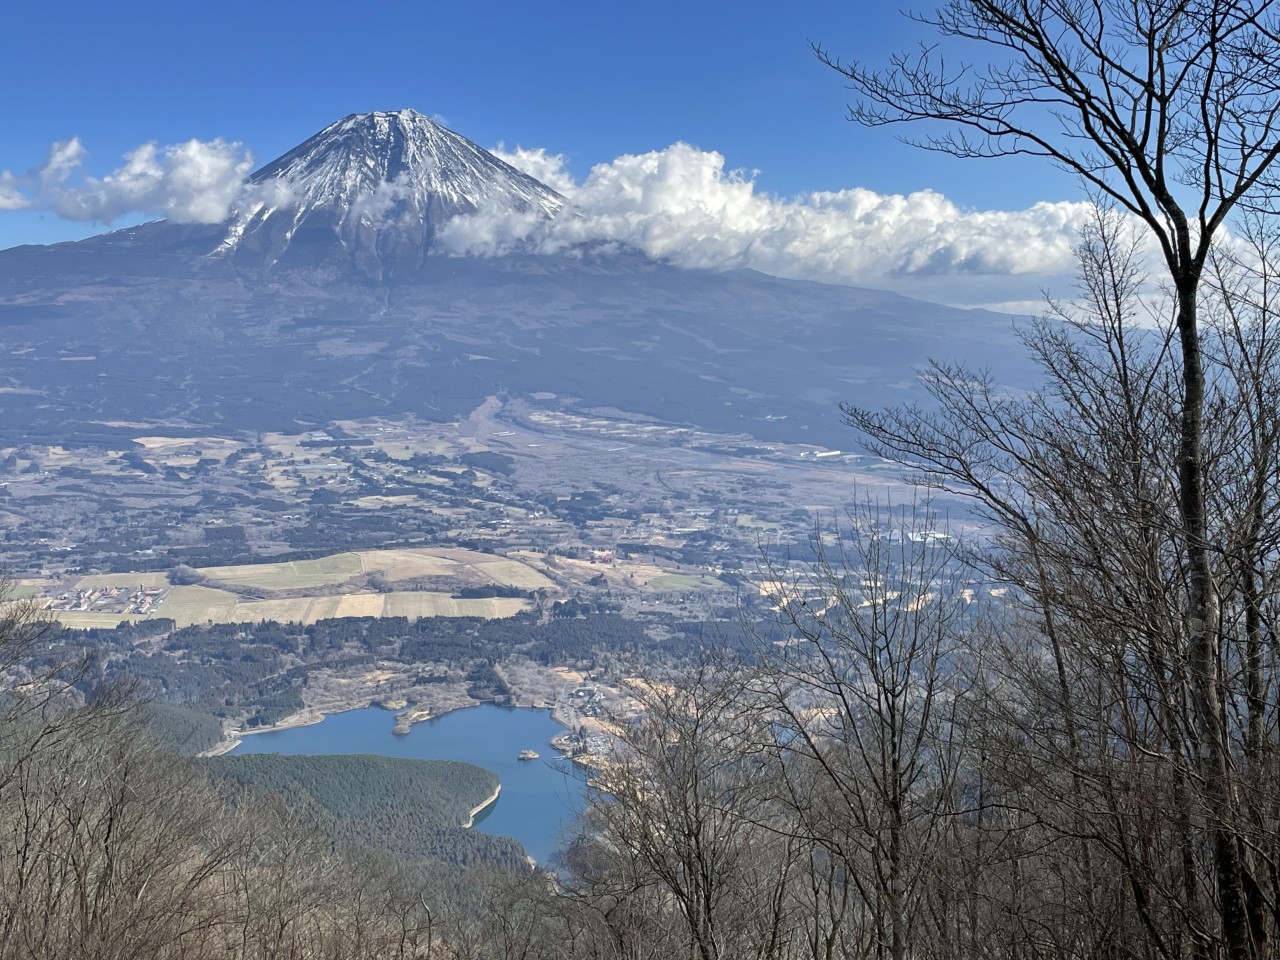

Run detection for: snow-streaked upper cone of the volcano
[[219, 110, 566, 278]]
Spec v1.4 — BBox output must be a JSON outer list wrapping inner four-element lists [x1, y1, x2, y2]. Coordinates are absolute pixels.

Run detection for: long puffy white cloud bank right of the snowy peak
[[439, 143, 1089, 308]]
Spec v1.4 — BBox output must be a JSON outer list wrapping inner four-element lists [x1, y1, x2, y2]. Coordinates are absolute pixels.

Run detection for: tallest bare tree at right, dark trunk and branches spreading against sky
[[815, 0, 1280, 960]]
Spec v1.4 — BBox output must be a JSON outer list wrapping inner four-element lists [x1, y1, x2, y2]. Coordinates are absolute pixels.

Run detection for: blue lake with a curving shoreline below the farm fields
[[234, 704, 585, 865]]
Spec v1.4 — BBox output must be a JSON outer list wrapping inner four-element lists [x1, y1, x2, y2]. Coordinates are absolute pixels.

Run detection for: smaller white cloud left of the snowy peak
[[0, 137, 253, 223]]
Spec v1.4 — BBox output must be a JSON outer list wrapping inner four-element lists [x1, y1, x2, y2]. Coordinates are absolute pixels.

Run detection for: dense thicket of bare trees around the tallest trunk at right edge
[[846, 200, 1280, 957]]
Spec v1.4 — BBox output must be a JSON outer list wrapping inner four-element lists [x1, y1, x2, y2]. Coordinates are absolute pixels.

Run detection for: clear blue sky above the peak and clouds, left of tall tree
[[0, 0, 1095, 308]]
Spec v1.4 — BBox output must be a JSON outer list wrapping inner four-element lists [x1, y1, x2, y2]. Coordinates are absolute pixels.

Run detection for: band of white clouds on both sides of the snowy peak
[[0, 138, 1088, 303]]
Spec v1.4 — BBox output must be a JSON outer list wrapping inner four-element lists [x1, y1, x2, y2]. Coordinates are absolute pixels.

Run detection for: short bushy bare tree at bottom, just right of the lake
[[571, 660, 804, 960]]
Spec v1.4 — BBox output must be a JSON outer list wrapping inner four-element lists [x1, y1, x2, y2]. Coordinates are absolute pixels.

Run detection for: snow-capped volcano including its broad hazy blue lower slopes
[[0, 110, 1028, 445]]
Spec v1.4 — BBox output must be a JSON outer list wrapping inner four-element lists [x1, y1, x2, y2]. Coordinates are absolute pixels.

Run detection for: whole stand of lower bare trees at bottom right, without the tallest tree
[[552, 211, 1280, 960]]
